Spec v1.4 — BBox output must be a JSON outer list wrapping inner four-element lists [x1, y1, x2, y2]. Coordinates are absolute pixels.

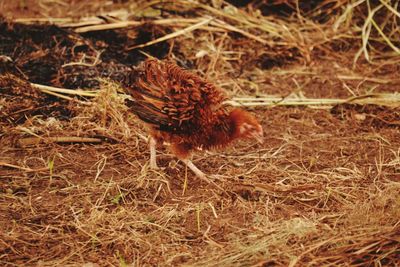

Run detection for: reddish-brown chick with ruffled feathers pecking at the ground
[[127, 59, 263, 178]]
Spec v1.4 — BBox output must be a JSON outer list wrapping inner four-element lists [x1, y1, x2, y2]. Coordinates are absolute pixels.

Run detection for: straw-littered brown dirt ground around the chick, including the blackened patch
[[0, 1, 400, 267]]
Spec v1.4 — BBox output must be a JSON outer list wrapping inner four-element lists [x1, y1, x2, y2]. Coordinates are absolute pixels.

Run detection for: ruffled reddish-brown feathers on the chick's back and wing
[[128, 59, 225, 135]]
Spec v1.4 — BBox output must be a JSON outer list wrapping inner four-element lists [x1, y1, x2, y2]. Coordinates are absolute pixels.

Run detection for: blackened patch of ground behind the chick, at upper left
[[0, 20, 169, 89]]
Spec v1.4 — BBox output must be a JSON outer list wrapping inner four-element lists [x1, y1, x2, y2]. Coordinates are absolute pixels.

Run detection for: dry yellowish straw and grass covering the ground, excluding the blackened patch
[[0, 0, 400, 266]]
